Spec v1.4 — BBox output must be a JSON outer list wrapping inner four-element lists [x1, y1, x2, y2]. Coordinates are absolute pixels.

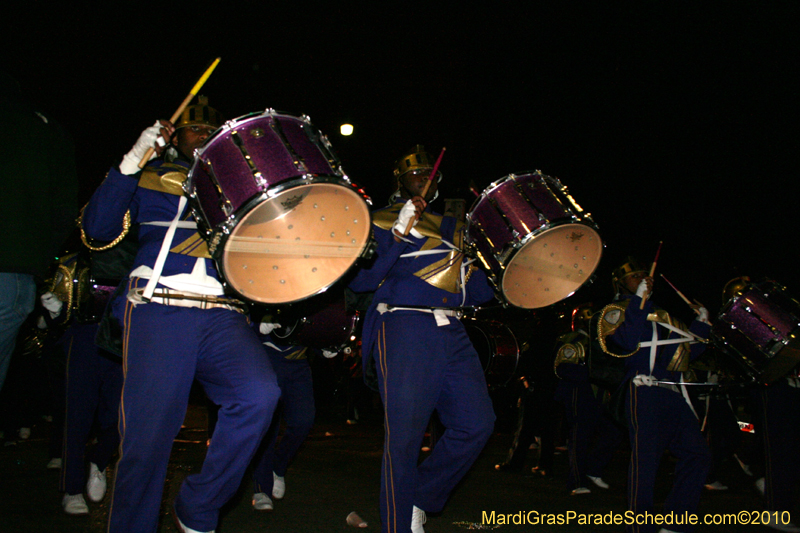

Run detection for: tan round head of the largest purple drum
[[221, 183, 371, 304]]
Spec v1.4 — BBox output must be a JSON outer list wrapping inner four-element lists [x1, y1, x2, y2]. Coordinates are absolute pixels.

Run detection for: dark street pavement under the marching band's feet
[[0, 382, 788, 533]]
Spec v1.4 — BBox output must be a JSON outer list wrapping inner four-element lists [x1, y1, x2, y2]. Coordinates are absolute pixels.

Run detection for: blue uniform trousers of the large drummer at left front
[[109, 298, 280, 533]]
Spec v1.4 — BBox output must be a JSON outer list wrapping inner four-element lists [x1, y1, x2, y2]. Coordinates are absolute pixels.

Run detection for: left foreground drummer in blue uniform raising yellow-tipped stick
[[83, 96, 280, 533]]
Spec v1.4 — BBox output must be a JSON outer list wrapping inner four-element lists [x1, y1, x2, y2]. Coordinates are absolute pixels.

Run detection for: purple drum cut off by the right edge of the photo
[[711, 281, 800, 384]]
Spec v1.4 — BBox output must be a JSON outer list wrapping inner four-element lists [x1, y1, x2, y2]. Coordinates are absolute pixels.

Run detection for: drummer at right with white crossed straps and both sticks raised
[[598, 257, 711, 533]]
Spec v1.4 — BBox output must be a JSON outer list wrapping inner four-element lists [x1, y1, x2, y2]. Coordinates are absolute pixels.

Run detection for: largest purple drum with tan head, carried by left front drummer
[[184, 110, 371, 304]]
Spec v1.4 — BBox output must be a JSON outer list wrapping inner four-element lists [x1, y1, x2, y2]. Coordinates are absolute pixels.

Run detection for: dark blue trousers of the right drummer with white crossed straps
[[625, 381, 711, 533]]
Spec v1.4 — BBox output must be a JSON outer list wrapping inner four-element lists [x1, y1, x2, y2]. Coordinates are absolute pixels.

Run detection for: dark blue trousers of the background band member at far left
[[61, 324, 122, 494]]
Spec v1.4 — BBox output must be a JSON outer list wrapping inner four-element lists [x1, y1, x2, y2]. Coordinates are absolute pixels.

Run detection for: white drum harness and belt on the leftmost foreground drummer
[[123, 195, 246, 314]]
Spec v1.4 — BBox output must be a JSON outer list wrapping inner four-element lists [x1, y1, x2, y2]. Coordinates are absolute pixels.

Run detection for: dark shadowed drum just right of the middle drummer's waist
[[461, 318, 519, 387]]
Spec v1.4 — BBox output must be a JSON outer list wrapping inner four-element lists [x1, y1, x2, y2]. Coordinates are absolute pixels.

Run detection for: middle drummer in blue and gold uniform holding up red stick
[[350, 145, 495, 533]]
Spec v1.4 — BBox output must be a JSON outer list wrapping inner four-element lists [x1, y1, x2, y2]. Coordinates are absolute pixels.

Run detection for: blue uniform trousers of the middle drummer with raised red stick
[[373, 311, 495, 533]]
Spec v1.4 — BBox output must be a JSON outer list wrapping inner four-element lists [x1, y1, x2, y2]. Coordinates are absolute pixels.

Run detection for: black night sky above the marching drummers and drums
[[7, 1, 800, 316]]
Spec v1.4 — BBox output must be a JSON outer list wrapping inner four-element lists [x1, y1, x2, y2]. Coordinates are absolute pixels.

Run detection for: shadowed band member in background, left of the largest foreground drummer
[[41, 247, 125, 515]]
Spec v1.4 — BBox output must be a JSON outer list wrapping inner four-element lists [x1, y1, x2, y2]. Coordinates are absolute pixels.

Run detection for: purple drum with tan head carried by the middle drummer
[[466, 171, 603, 309]]
